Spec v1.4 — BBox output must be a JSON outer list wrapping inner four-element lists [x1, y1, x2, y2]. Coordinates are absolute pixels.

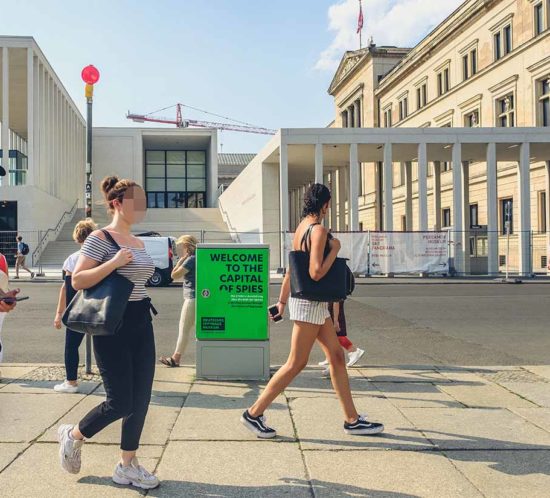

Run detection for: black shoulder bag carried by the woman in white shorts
[[289, 223, 355, 302]]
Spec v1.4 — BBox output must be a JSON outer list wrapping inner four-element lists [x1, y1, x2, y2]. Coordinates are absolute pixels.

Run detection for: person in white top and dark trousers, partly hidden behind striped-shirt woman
[[53, 218, 97, 393]]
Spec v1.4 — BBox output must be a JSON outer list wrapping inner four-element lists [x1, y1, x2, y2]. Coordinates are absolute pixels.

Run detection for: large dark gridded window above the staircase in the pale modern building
[[145, 150, 206, 208]]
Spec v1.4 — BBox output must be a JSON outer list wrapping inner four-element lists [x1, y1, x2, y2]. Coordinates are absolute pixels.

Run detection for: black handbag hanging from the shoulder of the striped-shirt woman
[[62, 230, 134, 336]]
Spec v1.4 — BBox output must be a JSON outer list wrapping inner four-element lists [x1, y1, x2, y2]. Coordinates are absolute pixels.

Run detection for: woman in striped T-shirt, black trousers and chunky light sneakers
[[58, 176, 159, 489]]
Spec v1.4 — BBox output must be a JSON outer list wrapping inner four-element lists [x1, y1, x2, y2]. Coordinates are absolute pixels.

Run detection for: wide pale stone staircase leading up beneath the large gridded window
[[40, 207, 233, 268]]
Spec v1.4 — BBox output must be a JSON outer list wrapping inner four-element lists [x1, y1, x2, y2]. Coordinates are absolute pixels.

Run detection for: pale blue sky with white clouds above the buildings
[[0, 0, 460, 152]]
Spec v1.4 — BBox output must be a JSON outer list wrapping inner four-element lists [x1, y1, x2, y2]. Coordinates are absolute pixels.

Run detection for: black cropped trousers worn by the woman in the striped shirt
[[78, 299, 155, 451]]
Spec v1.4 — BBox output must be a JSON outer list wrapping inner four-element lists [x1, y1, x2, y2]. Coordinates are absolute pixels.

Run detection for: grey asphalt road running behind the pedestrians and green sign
[[2, 279, 550, 365]]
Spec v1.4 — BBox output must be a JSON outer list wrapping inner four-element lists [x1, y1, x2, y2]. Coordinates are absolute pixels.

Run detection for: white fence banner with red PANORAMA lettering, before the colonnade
[[370, 232, 449, 274]]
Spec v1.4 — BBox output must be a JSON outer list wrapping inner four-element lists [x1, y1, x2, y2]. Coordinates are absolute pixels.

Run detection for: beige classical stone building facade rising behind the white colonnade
[[325, 0, 550, 272]]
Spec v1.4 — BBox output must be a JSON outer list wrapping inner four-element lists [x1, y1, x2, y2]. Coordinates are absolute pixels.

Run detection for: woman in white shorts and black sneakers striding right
[[241, 183, 384, 439]]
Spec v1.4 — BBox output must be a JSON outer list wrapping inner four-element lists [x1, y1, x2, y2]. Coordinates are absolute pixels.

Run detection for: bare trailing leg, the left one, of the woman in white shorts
[[248, 322, 322, 417]]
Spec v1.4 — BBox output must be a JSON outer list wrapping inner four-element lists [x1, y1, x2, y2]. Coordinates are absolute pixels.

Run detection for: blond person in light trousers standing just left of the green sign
[[159, 235, 198, 367]]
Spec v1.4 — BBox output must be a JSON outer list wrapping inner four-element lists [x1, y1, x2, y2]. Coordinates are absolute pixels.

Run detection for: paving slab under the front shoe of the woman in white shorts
[[290, 397, 433, 450]]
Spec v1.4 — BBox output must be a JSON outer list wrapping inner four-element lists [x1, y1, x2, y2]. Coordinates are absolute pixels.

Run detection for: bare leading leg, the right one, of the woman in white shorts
[[317, 319, 358, 422]]
